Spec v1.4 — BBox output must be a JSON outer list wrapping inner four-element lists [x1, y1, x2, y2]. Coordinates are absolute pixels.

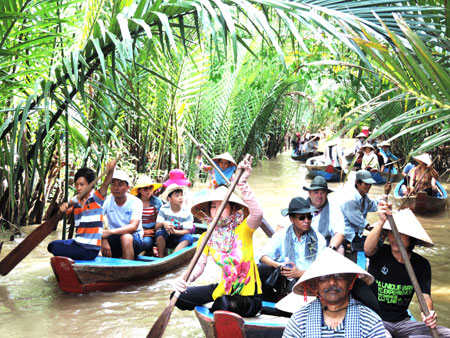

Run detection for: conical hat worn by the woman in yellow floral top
[[191, 186, 249, 219]]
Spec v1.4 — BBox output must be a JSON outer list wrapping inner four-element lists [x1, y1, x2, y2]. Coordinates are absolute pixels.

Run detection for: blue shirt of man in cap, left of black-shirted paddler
[[341, 188, 378, 242]]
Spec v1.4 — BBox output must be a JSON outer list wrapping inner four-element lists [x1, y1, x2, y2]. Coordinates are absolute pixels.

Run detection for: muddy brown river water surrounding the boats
[[0, 152, 450, 337]]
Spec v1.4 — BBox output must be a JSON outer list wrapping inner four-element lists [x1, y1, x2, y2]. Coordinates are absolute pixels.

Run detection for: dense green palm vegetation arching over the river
[[0, 0, 450, 231]]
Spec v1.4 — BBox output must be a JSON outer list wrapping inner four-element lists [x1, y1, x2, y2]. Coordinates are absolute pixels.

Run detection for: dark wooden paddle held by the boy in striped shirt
[[0, 164, 112, 276]]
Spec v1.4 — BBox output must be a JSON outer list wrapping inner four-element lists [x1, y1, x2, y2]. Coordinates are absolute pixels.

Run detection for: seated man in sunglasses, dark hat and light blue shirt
[[258, 197, 326, 302]]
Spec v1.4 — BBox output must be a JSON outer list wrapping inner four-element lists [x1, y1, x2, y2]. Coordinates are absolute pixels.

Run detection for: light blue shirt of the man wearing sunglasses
[[259, 227, 327, 270]]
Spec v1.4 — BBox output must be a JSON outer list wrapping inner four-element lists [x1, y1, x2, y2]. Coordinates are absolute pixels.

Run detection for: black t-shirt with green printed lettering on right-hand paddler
[[369, 244, 431, 322]]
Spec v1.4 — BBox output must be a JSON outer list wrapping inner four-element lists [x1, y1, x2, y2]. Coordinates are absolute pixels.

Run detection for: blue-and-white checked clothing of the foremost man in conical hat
[[283, 295, 386, 338]]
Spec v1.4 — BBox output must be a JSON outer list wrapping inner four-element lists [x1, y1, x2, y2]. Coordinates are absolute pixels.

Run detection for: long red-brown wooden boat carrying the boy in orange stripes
[[50, 234, 200, 293]]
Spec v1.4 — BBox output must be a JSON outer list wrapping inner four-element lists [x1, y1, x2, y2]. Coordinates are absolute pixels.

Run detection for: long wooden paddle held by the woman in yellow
[[147, 154, 251, 338]]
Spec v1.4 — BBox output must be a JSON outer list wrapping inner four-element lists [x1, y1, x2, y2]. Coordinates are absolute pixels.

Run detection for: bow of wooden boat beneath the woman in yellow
[[195, 302, 289, 338]]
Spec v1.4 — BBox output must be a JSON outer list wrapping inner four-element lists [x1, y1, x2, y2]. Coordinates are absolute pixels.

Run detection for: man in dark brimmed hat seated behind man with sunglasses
[[303, 176, 345, 254]]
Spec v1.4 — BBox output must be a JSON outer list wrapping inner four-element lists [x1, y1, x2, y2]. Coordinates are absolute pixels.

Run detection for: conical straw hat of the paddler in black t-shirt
[[383, 209, 434, 247]]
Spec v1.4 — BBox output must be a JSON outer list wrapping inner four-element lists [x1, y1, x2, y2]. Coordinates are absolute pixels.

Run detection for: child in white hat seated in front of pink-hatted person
[[155, 184, 194, 257]]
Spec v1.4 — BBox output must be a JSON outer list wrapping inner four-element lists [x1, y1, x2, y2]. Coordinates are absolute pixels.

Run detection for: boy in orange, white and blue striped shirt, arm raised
[[47, 160, 116, 260]]
